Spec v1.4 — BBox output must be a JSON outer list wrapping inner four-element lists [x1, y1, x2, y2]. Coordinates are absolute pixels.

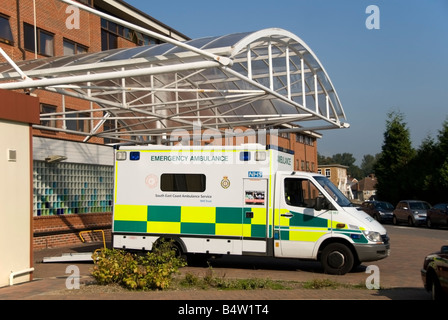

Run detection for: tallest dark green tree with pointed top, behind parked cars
[[374, 111, 415, 203]]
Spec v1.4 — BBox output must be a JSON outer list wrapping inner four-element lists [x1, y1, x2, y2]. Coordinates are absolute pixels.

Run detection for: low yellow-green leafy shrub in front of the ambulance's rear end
[[92, 241, 186, 290]]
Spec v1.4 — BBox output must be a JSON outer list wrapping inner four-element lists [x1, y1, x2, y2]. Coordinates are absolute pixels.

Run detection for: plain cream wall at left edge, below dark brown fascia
[[0, 120, 32, 287]]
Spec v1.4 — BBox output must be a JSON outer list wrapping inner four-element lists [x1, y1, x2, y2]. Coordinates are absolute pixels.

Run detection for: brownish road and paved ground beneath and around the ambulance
[[0, 225, 442, 301]]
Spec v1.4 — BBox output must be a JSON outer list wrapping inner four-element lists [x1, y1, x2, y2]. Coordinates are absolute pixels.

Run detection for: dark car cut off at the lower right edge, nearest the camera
[[421, 246, 448, 300]]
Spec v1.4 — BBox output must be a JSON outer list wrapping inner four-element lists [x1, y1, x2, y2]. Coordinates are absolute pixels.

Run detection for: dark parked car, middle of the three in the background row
[[392, 200, 431, 226]]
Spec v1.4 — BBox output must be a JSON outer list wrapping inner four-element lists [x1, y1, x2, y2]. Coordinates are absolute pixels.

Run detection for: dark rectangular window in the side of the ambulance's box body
[[160, 173, 206, 192]]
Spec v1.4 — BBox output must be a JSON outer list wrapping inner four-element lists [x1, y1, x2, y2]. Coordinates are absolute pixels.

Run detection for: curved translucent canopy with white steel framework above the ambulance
[[0, 28, 348, 142]]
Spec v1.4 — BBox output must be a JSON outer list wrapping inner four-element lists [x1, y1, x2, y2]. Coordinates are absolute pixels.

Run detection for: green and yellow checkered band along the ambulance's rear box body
[[114, 205, 267, 238]]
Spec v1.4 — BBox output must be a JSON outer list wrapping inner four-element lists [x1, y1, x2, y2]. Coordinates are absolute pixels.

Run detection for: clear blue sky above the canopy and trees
[[125, 0, 448, 165]]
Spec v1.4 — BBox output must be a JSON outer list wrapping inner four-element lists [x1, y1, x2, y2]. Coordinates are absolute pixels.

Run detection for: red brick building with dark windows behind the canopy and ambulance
[[0, 0, 345, 248]]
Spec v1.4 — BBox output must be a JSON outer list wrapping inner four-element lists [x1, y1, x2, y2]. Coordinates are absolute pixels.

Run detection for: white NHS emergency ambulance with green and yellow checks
[[112, 144, 390, 274]]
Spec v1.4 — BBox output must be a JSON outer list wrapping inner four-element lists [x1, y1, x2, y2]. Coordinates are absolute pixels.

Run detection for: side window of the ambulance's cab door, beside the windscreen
[[285, 178, 319, 208]]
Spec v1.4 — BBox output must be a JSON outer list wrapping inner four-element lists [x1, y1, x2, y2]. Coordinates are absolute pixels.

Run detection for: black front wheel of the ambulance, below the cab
[[320, 243, 355, 275]]
